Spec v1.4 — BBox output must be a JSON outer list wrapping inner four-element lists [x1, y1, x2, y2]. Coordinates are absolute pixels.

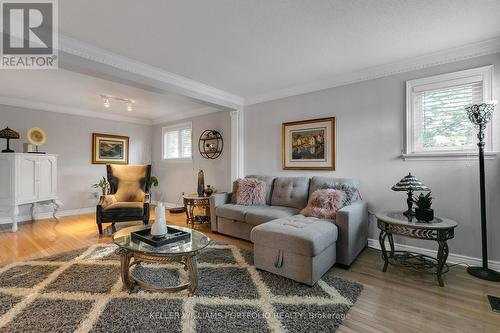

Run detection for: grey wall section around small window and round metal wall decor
[[152, 112, 231, 205]]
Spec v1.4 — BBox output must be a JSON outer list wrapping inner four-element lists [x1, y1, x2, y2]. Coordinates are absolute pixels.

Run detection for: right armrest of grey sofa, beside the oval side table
[[335, 200, 368, 266]]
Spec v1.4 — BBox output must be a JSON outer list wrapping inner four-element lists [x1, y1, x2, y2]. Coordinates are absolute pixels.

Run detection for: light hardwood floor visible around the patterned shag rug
[[0, 214, 500, 333]]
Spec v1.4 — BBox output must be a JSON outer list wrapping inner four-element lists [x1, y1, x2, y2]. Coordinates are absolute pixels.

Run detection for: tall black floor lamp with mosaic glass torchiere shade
[[465, 101, 500, 282]]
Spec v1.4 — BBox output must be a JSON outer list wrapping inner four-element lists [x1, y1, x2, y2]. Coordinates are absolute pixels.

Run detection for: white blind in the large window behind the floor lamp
[[413, 81, 483, 151]]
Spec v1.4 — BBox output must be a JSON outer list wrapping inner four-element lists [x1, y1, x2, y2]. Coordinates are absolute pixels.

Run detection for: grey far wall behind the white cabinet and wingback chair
[[0, 105, 152, 215]]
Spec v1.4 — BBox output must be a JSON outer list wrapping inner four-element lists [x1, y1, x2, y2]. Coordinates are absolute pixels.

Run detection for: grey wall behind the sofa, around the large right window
[[244, 54, 500, 260]]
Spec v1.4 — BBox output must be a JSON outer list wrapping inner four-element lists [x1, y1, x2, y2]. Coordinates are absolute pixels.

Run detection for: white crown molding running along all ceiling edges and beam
[[0, 35, 500, 125]]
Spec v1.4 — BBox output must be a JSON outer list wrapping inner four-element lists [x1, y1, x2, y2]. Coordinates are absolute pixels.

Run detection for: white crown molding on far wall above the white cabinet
[[0, 96, 153, 126]]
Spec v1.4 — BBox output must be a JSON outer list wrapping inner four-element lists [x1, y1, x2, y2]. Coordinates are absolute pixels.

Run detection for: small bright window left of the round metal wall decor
[[162, 123, 192, 160]]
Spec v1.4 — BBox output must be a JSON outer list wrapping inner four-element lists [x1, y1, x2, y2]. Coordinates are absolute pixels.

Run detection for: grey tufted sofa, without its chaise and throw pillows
[[210, 175, 368, 266]]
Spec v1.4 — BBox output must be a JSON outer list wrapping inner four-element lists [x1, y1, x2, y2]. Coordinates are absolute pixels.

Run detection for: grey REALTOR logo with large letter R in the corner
[[0, 0, 58, 69]]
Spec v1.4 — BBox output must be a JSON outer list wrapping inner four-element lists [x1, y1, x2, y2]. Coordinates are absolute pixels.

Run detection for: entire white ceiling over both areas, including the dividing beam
[[0, 0, 500, 124]]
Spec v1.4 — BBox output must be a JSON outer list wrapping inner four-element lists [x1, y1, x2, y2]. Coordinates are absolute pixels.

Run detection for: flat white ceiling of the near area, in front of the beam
[[59, 0, 500, 99]]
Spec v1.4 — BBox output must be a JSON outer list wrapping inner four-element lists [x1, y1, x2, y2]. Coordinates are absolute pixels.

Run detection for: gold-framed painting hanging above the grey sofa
[[282, 117, 336, 170]]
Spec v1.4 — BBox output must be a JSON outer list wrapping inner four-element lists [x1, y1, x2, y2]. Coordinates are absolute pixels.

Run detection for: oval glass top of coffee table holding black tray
[[113, 224, 210, 256]]
